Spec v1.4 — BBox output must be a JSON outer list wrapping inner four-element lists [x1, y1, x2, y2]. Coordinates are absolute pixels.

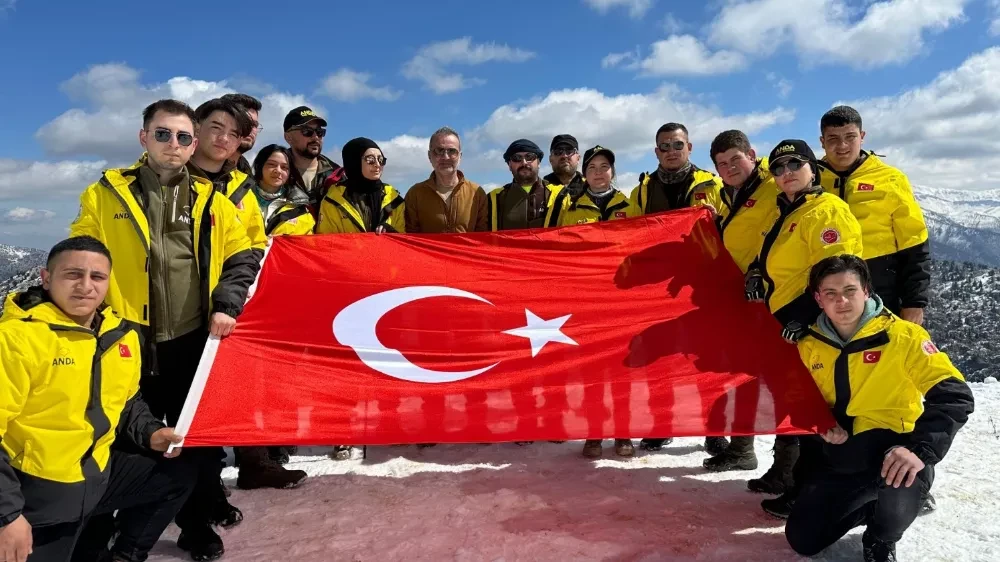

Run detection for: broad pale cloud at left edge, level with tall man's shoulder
[[0, 158, 106, 201]]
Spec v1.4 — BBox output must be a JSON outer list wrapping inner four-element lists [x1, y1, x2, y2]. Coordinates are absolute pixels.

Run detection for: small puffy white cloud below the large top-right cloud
[[632, 35, 746, 76]]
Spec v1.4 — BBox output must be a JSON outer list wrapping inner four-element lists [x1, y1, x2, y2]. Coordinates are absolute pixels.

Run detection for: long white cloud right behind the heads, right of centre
[[470, 86, 794, 159]]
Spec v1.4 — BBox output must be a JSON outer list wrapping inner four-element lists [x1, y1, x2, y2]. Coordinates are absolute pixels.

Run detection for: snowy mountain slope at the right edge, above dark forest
[[913, 185, 1000, 267]]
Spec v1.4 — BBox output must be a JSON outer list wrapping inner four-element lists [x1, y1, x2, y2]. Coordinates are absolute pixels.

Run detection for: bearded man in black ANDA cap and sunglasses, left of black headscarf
[[284, 105, 344, 210]]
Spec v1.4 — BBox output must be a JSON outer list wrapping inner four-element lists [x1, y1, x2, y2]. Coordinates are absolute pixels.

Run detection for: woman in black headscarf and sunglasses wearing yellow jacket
[[316, 137, 406, 234]]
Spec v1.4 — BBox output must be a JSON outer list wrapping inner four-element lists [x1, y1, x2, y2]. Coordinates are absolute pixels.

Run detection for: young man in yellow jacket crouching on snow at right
[[785, 255, 974, 562]]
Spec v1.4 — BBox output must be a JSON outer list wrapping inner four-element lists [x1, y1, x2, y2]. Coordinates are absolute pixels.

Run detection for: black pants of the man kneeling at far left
[[28, 450, 196, 562]]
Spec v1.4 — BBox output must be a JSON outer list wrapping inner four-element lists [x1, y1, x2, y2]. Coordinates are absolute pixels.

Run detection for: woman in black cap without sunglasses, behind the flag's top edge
[[545, 145, 642, 226]]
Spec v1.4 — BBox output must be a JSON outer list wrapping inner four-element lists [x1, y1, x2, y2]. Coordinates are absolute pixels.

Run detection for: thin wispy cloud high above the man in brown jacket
[[403, 37, 535, 94]]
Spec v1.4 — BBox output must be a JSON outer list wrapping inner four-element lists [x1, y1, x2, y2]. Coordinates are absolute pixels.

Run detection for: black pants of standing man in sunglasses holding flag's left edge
[[141, 330, 227, 530]]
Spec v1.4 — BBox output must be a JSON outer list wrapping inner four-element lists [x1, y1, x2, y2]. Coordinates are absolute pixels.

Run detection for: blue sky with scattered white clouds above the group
[[0, 0, 1000, 247]]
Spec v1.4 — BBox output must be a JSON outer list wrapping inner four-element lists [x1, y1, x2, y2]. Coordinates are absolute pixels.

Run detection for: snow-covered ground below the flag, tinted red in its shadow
[[150, 384, 1000, 562]]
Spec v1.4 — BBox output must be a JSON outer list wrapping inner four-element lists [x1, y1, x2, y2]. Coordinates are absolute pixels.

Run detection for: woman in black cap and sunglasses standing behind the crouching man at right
[[744, 140, 861, 498]]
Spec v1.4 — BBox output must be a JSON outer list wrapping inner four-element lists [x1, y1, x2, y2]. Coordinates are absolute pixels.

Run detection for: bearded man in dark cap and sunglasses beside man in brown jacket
[[487, 139, 568, 232]]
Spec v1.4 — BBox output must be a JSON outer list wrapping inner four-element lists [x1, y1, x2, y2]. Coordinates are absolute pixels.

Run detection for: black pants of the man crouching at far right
[[785, 453, 934, 556]]
